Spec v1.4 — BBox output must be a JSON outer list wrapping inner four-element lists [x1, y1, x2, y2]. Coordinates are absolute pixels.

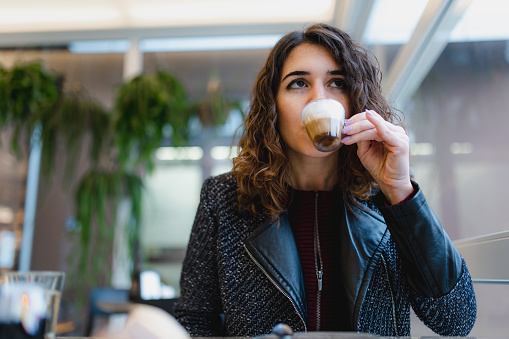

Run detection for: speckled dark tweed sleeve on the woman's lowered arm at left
[[175, 179, 222, 336]]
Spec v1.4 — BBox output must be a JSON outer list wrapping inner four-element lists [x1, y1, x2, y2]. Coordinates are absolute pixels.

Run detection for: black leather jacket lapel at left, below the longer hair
[[244, 214, 307, 325]]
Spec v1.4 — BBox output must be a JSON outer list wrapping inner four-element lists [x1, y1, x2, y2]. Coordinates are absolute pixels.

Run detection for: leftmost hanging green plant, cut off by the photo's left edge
[[0, 62, 62, 153]]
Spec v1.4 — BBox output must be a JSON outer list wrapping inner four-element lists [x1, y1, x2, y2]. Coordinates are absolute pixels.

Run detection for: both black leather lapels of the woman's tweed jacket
[[244, 204, 389, 329]]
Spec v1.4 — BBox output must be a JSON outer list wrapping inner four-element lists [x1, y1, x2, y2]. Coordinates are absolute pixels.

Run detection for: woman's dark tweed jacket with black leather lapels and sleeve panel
[[175, 174, 476, 336]]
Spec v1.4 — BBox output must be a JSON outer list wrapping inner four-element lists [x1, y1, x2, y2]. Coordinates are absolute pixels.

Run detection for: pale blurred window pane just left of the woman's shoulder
[[140, 161, 203, 295]]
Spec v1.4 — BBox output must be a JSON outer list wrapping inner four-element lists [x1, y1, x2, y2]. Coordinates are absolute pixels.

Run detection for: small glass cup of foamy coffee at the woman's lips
[[301, 99, 345, 152]]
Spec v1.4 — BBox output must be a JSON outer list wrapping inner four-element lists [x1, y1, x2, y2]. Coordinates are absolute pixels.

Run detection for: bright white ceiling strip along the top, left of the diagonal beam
[[0, 0, 366, 46]]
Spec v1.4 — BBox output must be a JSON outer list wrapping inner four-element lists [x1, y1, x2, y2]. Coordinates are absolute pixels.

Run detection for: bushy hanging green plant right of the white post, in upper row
[[114, 71, 190, 169]]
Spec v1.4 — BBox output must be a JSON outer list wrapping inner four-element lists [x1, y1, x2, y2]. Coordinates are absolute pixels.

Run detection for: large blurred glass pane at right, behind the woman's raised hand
[[404, 1, 509, 239]]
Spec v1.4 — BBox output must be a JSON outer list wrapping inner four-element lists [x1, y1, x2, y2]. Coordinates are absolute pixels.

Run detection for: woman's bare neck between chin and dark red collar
[[289, 152, 338, 191]]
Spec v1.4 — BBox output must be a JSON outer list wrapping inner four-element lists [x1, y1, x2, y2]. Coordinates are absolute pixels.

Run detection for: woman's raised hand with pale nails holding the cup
[[341, 110, 413, 204]]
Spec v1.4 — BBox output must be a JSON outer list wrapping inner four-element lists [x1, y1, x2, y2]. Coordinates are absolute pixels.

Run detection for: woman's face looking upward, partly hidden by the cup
[[276, 43, 350, 157]]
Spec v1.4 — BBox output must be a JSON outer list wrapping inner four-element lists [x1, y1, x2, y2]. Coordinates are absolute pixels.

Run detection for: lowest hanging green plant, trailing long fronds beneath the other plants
[[69, 169, 143, 305]]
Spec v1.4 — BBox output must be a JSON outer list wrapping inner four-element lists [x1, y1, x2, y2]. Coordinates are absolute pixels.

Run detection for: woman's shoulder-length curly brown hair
[[232, 24, 400, 219]]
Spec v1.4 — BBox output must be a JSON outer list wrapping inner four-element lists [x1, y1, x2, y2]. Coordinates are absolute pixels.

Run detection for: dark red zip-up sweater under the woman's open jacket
[[288, 190, 351, 331]]
